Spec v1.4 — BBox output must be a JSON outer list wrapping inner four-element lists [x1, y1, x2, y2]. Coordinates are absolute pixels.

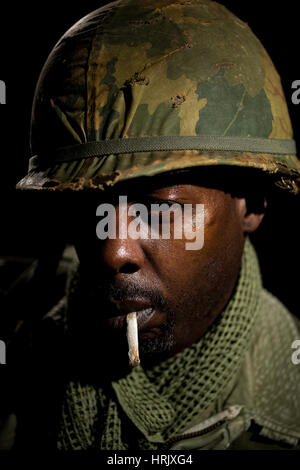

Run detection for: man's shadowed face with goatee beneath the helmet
[[71, 178, 251, 366]]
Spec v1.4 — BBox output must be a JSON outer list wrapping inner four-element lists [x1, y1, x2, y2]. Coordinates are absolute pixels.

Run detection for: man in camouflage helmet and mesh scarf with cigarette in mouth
[[5, 0, 300, 450]]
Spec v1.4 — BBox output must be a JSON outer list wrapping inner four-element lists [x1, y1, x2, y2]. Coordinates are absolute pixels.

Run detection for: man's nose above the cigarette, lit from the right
[[101, 206, 145, 274]]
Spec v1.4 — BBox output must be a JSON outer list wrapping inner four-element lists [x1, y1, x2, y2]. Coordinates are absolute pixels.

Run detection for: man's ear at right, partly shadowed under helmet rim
[[237, 198, 267, 233]]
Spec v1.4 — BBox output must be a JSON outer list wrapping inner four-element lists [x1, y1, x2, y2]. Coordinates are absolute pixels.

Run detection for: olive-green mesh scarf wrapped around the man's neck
[[57, 240, 262, 450]]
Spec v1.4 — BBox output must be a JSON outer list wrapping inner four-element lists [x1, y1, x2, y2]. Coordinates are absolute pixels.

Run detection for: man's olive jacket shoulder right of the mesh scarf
[[228, 289, 300, 448]]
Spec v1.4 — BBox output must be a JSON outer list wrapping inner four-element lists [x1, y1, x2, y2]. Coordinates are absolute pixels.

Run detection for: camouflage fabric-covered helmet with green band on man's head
[[17, 0, 300, 193]]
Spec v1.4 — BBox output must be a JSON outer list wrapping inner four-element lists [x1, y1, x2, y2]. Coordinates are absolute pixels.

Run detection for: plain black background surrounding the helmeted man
[[0, 0, 300, 316]]
